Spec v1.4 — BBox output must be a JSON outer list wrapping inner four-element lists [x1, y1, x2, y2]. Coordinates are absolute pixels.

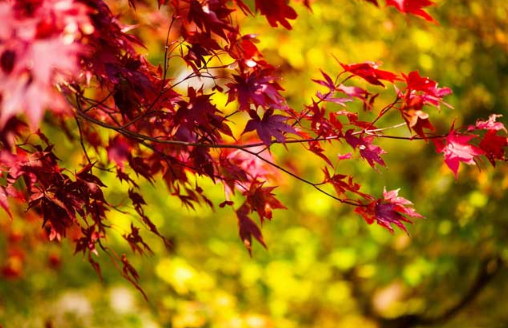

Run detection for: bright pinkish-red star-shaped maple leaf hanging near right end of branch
[[433, 130, 485, 179]]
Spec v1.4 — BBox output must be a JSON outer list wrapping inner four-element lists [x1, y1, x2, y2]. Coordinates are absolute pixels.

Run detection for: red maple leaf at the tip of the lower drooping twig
[[355, 188, 424, 233]]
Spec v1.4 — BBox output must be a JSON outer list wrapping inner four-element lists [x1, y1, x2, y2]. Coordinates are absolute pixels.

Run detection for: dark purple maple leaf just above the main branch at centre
[[242, 108, 297, 146]]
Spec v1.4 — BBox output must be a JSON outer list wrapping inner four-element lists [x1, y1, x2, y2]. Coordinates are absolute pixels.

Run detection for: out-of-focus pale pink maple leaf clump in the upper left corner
[[0, 0, 93, 128]]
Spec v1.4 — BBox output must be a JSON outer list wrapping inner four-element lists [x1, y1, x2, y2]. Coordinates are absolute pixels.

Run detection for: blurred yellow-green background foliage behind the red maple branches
[[0, 0, 508, 328]]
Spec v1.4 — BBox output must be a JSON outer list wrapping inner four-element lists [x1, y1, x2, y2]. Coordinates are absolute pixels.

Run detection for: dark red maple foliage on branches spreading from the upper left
[[0, 0, 508, 284]]
